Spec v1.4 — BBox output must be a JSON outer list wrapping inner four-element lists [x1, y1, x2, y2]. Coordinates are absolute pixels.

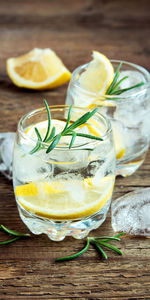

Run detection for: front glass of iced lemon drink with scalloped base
[[13, 105, 116, 241]]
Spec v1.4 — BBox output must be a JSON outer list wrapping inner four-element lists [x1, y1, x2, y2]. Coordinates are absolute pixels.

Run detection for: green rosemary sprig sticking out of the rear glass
[[106, 62, 144, 96]]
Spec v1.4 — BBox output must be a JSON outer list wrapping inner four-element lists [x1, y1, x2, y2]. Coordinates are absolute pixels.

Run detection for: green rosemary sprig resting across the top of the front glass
[[30, 100, 103, 154]]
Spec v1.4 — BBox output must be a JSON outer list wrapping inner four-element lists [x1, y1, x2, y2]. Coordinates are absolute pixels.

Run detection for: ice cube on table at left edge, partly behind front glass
[[0, 132, 15, 179]]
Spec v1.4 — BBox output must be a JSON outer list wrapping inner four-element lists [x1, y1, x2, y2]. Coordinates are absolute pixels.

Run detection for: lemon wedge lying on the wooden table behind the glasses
[[7, 48, 71, 90]]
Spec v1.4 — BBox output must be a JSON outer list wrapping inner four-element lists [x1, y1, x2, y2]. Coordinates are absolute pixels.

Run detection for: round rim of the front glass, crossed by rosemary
[[17, 105, 112, 151]]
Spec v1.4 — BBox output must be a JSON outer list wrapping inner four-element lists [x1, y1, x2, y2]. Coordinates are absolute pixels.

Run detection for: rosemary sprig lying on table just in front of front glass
[[55, 232, 125, 262]]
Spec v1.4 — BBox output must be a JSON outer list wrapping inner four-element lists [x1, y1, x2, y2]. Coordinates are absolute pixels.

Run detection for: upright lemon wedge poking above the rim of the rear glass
[[79, 51, 114, 94]]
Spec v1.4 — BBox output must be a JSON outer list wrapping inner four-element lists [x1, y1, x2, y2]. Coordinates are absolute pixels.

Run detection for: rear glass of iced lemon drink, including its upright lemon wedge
[[66, 52, 150, 176]]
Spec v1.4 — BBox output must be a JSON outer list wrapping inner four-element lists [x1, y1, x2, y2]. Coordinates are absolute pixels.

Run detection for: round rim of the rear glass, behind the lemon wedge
[[70, 59, 150, 103]]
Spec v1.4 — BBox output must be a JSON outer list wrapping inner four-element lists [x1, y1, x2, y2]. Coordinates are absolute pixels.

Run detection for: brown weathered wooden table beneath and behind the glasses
[[0, 0, 150, 299]]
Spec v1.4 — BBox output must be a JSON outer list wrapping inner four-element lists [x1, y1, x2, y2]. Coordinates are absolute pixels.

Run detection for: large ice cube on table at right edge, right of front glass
[[112, 188, 150, 236]]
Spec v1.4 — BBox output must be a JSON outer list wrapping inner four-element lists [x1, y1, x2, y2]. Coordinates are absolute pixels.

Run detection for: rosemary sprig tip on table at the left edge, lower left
[[0, 225, 30, 245]]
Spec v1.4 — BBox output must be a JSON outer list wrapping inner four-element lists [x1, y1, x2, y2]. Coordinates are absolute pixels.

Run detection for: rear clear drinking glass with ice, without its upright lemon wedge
[[66, 60, 150, 176]]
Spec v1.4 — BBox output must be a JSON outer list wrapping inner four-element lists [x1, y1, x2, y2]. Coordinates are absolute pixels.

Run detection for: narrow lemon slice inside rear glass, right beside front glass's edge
[[111, 123, 126, 159]]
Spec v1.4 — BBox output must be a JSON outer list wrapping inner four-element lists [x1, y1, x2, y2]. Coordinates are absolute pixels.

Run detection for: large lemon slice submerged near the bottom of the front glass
[[15, 176, 114, 220]]
